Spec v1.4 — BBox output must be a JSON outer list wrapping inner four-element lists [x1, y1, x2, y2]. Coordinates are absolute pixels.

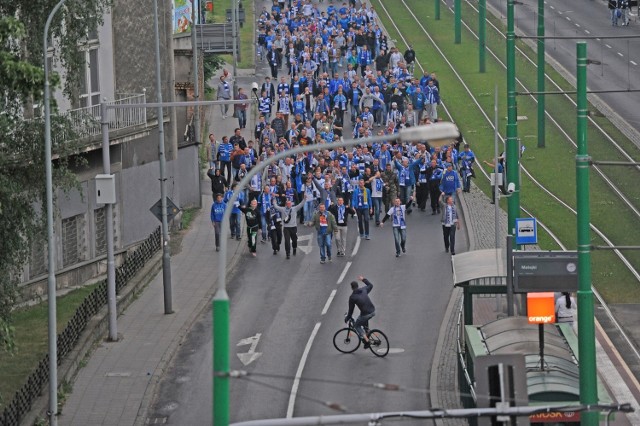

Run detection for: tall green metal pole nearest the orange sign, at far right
[[576, 41, 598, 426]]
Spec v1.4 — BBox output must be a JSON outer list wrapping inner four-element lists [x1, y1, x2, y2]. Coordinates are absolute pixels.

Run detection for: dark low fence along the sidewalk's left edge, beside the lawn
[[0, 227, 162, 426]]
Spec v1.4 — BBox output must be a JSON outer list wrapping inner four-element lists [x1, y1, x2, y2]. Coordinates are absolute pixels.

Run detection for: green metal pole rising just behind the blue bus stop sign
[[506, 0, 520, 235]]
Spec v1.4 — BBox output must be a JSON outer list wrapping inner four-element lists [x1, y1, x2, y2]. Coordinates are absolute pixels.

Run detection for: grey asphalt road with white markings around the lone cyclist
[[150, 202, 467, 425]]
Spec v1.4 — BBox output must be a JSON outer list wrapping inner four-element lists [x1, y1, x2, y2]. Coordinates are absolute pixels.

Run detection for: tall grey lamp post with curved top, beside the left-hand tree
[[42, 0, 66, 426]]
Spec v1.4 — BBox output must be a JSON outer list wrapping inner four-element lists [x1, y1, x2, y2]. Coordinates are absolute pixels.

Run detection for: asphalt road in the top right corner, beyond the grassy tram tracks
[[488, 0, 640, 132]]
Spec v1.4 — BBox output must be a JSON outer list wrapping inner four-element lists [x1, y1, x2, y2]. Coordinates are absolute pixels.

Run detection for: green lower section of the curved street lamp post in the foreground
[[213, 289, 230, 426]]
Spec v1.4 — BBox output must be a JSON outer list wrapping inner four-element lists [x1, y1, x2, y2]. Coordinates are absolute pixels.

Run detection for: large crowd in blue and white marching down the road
[[207, 0, 476, 263]]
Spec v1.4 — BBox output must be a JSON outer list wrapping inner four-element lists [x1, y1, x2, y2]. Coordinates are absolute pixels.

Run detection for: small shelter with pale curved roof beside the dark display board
[[451, 249, 507, 325]]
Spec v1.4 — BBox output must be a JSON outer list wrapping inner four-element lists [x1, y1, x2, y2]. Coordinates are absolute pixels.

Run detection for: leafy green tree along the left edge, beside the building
[[0, 0, 110, 350]]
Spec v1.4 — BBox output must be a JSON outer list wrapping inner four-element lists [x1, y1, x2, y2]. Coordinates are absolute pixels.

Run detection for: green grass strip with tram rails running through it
[[372, 0, 640, 303]]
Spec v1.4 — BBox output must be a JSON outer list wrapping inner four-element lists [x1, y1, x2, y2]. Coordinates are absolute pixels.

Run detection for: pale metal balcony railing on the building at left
[[64, 92, 147, 138]]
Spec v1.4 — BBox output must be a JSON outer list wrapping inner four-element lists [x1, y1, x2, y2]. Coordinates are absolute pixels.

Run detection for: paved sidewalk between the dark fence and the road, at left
[[59, 69, 254, 426]]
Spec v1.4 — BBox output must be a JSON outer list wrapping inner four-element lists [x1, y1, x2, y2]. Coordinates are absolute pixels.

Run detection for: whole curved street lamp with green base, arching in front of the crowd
[[213, 122, 460, 426]]
